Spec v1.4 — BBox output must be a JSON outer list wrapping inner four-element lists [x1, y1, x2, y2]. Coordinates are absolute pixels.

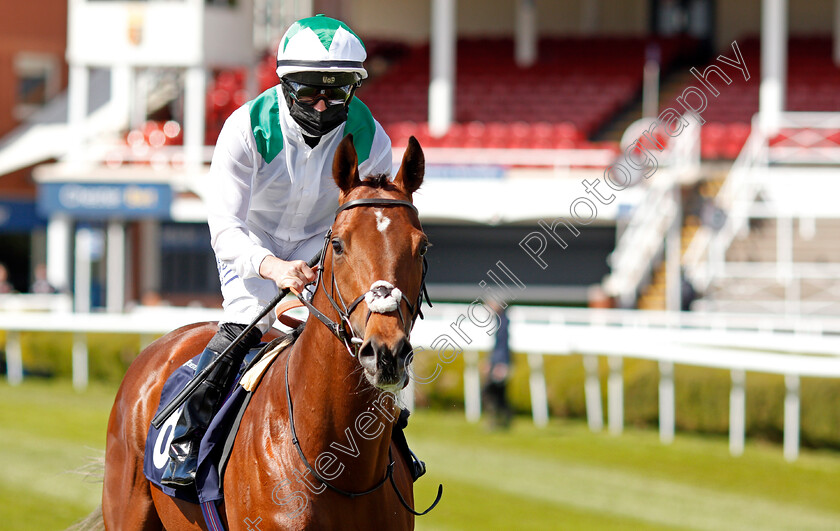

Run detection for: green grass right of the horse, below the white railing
[[408, 412, 840, 530]]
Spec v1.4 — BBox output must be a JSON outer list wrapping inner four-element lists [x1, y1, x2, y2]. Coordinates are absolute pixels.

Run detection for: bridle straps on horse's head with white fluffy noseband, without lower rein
[[298, 198, 432, 357]]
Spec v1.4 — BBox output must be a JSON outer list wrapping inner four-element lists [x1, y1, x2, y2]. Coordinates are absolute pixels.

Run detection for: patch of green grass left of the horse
[[0, 378, 116, 531]]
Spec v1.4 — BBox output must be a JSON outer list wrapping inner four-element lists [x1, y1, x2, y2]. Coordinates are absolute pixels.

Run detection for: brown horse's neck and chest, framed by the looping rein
[[283, 300, 395, 490]]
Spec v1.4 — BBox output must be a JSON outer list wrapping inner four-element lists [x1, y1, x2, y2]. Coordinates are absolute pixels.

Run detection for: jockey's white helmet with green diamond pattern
[[277, 15, 367, 79]]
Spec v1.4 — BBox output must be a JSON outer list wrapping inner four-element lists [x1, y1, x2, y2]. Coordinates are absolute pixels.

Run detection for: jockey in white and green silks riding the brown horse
[[162, 15, 391, 487]]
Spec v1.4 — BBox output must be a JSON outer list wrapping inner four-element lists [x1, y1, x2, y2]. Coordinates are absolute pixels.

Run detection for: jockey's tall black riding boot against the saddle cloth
[[161, 323, 262, 488]]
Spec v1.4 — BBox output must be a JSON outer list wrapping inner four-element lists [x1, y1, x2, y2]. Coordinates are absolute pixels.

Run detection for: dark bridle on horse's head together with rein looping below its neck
[[286, 198, 443, 516]]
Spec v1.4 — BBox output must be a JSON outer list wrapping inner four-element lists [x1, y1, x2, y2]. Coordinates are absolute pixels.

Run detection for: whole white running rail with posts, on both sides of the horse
[[0, 304, 840, 460]]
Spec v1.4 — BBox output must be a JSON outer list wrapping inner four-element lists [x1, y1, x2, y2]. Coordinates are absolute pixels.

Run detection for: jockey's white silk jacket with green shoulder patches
[[204, 85, 392, 279]]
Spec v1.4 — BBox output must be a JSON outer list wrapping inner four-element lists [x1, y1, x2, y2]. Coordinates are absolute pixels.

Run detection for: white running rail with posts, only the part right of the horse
[[412, 306, 840, 460]]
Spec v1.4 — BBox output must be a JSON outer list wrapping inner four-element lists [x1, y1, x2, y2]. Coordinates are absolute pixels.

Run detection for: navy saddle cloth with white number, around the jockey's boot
[[143, 345, 265, 503]]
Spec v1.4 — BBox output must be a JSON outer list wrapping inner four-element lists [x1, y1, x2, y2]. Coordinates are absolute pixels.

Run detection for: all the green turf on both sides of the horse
[[0, 379, 840, 531]]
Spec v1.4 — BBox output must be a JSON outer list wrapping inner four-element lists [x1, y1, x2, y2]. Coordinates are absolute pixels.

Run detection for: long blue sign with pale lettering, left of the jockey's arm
[[38, 183, 172, 219]]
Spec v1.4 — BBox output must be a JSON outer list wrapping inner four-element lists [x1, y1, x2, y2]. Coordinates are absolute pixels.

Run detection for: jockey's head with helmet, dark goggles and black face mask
[[277, 15, 367, 137]]
